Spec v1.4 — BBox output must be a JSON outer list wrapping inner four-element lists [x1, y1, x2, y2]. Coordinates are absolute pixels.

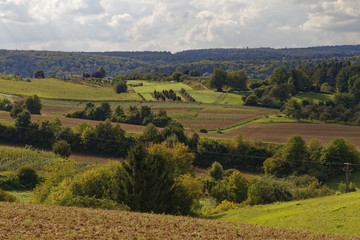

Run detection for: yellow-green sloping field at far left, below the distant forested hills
[[0, 78, 141, 101]]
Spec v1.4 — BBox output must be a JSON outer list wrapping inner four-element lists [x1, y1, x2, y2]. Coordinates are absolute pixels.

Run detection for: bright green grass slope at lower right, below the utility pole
[[211, 192, 360, 235]]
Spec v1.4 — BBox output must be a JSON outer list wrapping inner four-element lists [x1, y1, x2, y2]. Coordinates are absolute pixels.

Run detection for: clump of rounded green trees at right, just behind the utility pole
[[264, 136, 360, 181]]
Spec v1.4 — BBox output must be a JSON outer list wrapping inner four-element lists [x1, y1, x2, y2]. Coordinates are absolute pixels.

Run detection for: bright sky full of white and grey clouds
[[0, 0, 360, 52]]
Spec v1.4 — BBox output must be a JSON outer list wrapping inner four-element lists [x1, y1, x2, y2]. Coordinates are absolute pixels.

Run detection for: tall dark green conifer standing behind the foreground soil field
[[124, 144, 175, 213]]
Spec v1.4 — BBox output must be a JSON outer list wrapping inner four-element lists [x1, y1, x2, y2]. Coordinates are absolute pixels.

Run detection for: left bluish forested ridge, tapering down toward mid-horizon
[[0, 50, 149, 77]]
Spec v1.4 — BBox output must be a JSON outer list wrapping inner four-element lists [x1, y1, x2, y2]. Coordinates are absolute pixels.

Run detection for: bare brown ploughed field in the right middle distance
[[202, 123, 360, 149]]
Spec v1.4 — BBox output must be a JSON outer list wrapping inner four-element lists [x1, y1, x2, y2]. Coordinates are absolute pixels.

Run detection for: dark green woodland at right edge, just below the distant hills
[[244, 62, 360, 108]]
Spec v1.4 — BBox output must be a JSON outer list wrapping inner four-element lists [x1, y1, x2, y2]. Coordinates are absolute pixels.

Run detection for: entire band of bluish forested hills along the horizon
[[0, 45, 360, 79]]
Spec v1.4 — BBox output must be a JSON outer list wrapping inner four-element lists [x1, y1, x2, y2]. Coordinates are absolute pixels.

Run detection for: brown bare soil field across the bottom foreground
[[0, 203, 360, 240]]
